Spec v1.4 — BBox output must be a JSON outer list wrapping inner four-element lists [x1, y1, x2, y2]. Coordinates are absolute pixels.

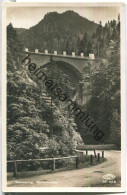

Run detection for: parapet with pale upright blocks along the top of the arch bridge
[[25, 48, 95, 60]]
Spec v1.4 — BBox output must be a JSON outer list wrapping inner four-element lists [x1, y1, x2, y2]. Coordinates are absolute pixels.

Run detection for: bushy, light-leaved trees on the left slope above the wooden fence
[[7, 24, 82, 160]]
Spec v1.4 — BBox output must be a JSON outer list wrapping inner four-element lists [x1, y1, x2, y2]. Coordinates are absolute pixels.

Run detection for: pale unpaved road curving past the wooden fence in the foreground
[[8, 150, 121, 187]]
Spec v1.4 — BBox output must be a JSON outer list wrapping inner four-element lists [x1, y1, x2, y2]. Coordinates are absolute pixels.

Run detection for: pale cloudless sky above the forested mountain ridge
[[7, 6, 119, 29]]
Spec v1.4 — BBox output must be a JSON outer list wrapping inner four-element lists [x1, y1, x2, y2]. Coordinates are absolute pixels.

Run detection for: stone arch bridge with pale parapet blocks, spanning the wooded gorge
[[25, 48, 96, 105]]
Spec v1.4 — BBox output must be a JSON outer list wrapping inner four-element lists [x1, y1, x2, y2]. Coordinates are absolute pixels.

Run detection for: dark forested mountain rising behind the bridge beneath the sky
[[18, 11, 98, 54]]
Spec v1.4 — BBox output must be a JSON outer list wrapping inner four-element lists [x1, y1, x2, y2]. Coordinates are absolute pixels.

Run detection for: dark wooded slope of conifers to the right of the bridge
[[77, 16, 121, 148]]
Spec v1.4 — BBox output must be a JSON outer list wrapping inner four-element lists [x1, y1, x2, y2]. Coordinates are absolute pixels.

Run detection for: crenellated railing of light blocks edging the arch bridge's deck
[[25, 48, 95, 60]]
